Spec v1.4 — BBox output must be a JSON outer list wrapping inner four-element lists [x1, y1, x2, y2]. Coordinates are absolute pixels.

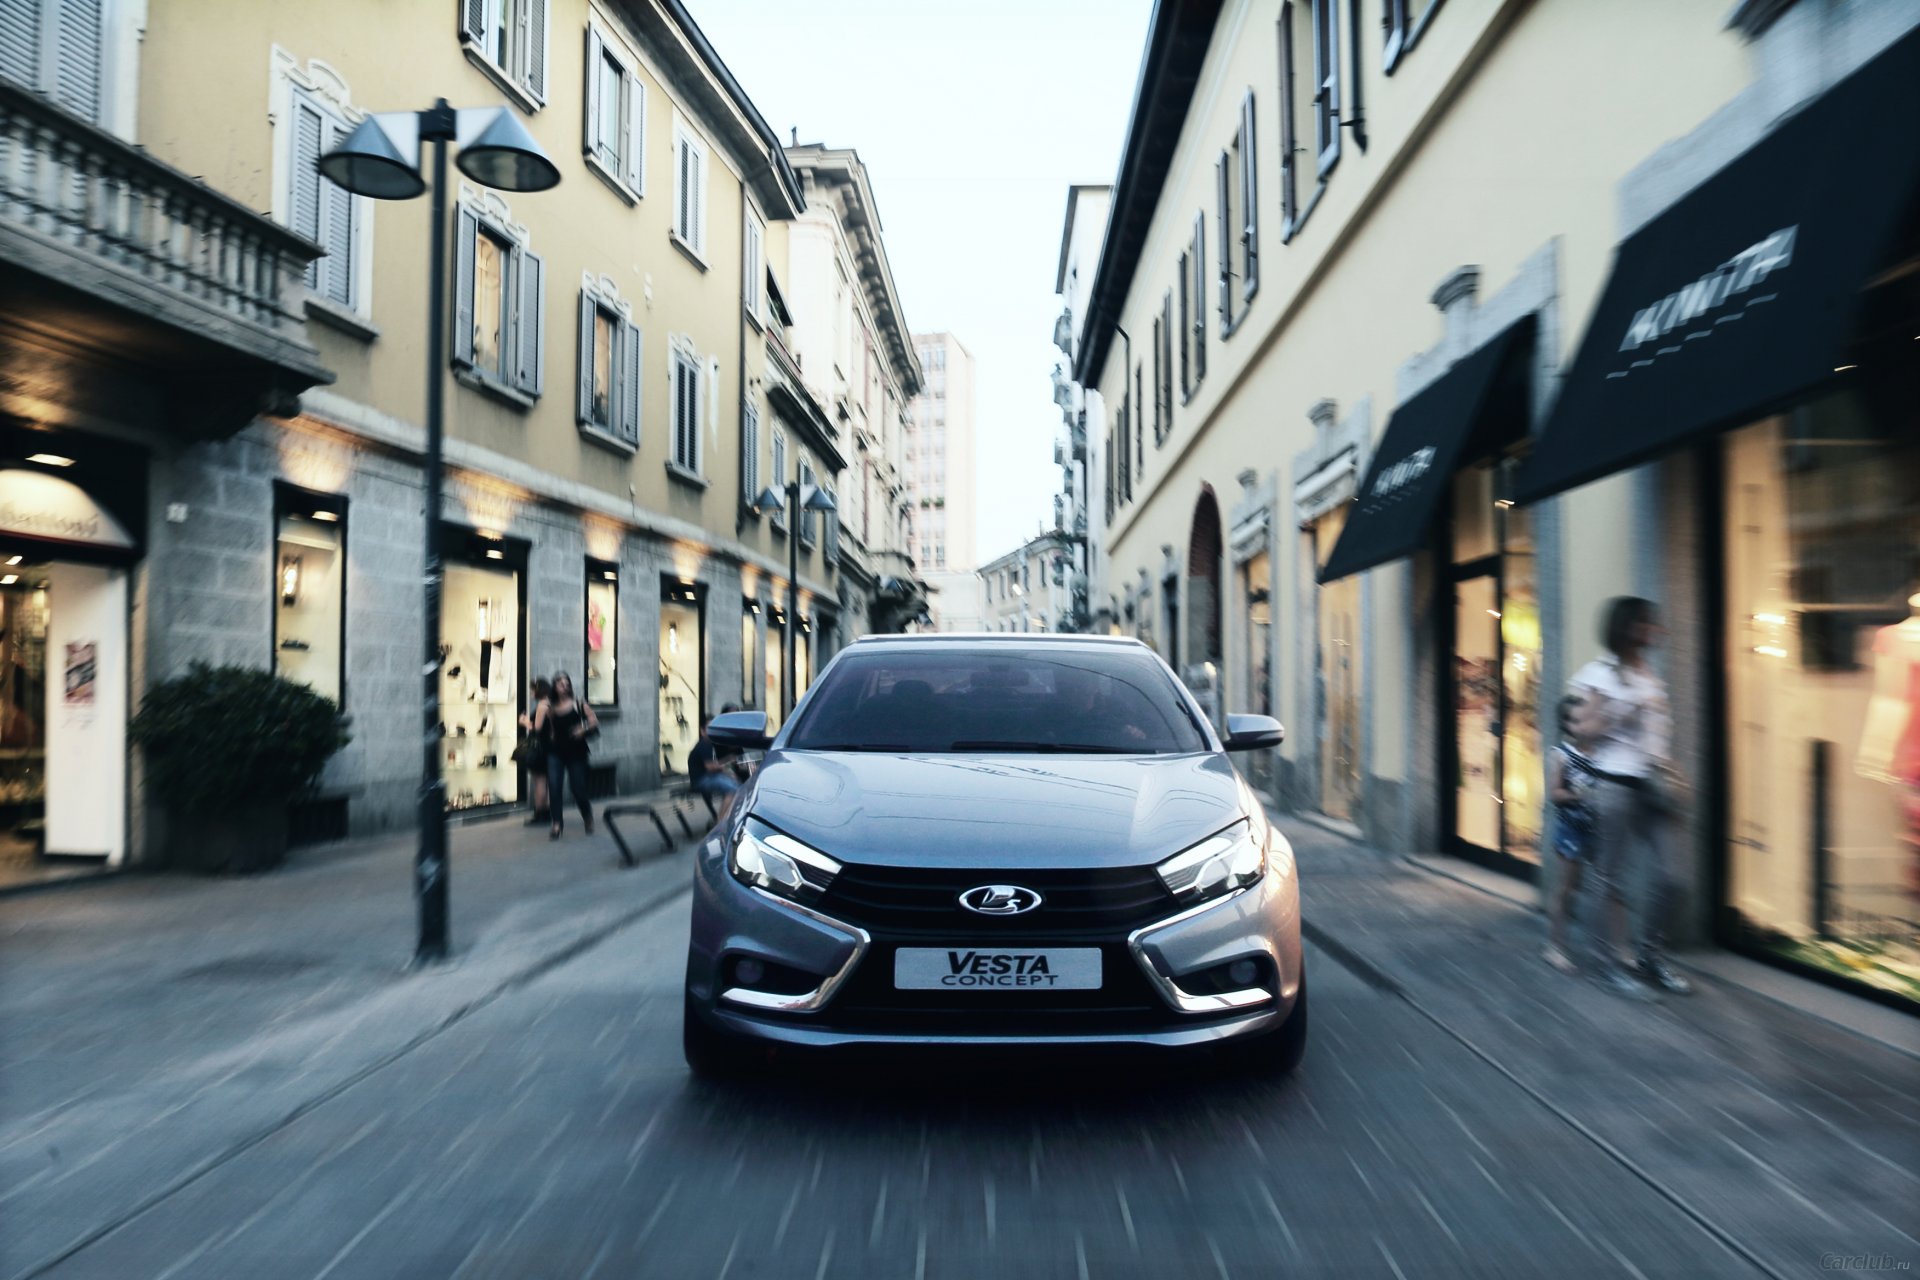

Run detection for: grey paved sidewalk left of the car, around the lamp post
[[0, 819, 689, 1276]]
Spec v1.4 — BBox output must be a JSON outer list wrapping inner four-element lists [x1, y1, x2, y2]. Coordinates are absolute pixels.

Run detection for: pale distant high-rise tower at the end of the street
[[906, 334, 975, 576]]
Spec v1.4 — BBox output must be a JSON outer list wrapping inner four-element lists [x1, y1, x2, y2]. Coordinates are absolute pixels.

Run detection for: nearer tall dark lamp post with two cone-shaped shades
[[319, 98, 561, 965]]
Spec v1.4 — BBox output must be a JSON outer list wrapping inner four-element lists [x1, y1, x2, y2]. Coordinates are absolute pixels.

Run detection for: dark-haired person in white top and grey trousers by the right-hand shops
[[1569, 595, 1693, 996]]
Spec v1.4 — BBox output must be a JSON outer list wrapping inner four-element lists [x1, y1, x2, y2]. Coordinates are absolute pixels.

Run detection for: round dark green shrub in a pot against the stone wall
[[129, 662, 349, 873]]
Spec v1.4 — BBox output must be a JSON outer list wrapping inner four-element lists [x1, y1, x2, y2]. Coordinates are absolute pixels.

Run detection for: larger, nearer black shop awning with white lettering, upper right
[[1517, 31, 1920, 501]]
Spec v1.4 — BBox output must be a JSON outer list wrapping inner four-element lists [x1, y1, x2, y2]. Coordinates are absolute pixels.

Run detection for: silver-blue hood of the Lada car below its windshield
[[747, 750, 1252, 869]]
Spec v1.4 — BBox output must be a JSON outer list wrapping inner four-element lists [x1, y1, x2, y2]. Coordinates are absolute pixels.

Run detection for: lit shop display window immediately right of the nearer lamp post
[[440, 537, 526, 810]]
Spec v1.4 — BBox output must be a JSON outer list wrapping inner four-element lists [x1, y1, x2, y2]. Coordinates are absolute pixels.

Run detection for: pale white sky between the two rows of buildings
[[687, 0, 1152, 564]]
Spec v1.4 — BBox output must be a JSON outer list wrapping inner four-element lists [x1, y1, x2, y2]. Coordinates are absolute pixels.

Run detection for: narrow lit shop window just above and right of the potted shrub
[[273, 486, 348, 702]]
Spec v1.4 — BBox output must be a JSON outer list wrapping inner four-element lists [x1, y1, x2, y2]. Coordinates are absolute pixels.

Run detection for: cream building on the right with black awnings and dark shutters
[[1075, 0, 1920, 996]]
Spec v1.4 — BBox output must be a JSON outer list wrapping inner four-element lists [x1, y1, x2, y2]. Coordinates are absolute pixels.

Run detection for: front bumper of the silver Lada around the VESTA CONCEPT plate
[[687, 837, 1302, 1048]]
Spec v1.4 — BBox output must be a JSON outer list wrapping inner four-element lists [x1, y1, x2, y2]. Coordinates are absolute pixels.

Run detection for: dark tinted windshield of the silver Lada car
[[785, 643, 1208, 756]]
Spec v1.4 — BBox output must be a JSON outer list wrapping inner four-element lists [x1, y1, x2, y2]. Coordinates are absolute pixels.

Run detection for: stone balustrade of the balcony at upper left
[[0, 79, 330, 391]]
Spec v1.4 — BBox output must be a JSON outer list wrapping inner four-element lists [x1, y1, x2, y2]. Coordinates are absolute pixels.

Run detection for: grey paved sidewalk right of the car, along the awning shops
[[1279, 819, 1920, 1274]]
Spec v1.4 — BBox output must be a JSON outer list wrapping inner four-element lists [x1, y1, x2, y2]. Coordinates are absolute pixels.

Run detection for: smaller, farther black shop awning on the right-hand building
[[1319, 315, 1534, 581]]
